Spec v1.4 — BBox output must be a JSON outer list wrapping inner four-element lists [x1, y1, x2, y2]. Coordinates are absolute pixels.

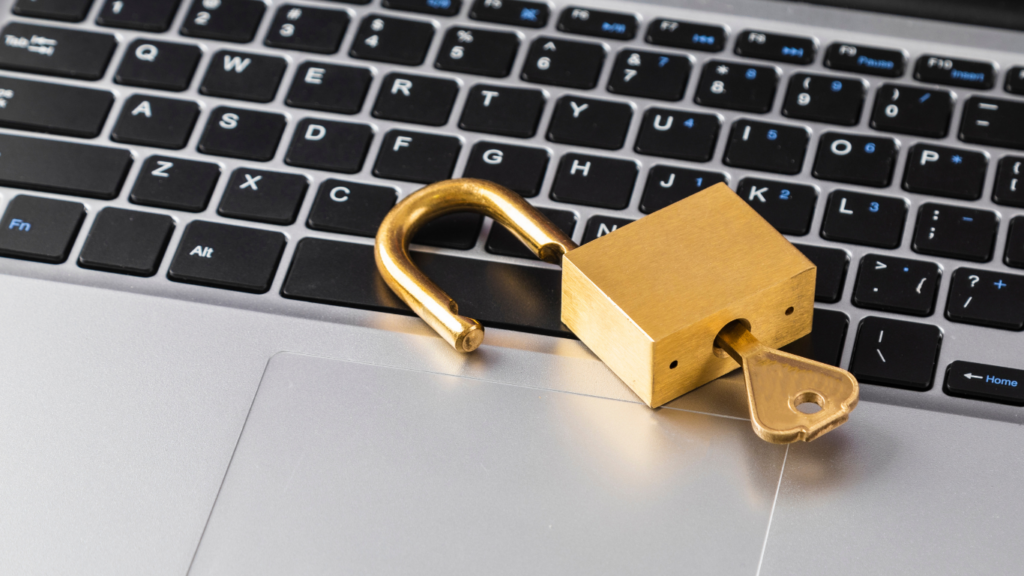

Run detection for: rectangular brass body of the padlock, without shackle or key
[[562, 183, 816, 407]]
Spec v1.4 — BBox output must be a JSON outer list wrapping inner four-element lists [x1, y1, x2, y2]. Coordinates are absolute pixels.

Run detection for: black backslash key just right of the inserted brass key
[[850, 317, 942, 390]]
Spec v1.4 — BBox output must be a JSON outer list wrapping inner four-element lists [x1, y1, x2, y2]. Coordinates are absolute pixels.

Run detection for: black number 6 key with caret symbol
[[522, 36, 604, 89]]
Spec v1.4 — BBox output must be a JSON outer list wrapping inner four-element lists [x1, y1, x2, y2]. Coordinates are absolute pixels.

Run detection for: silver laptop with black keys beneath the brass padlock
[[0, 0, 1024, 576]]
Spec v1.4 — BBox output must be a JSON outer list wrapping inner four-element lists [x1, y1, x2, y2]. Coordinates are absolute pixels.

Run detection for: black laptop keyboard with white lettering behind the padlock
[[0, 0, 1024, 412]]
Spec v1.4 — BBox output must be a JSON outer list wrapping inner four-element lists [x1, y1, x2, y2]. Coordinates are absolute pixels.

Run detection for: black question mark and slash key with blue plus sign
[[946, 268, 1024, 330]]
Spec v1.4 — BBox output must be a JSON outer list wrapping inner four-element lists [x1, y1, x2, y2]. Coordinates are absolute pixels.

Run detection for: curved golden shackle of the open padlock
[[374, 178, 577, 352]]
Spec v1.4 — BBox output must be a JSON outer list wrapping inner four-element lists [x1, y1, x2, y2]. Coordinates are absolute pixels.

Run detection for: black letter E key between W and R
[[285, 61, 373, 114]]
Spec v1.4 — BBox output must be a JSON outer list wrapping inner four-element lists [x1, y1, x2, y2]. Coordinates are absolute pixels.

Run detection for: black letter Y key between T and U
[[548, 96, 633, 150]]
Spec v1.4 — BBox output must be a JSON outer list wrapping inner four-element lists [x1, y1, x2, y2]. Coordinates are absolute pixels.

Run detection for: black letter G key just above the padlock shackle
[[462, 141, 549, 198]]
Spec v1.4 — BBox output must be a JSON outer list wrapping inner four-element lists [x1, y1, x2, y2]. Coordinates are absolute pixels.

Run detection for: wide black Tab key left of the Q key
[[0, 22, 118, 80]]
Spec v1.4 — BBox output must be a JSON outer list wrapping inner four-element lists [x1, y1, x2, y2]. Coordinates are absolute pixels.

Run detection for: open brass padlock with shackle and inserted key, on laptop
[[374, 178, 858, 444]]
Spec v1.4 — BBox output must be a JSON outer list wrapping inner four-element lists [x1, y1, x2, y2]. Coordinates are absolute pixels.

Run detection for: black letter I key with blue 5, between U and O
[[722, 120, 810, 174]]
